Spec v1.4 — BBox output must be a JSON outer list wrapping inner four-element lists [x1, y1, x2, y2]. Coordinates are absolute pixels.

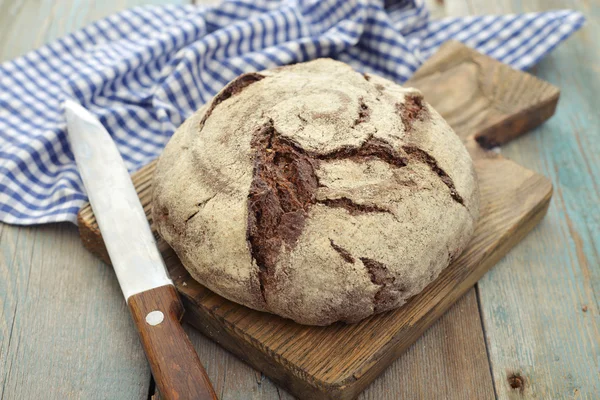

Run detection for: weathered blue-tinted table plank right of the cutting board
[[447, 0, 600, 399]]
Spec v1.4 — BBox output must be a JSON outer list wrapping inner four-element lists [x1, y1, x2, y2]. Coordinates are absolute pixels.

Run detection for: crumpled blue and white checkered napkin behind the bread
[[0, 0, 584, 225]]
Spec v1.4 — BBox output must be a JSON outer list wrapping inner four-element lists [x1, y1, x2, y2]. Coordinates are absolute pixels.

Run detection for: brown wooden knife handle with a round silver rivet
[[127, 285, 217, 400]]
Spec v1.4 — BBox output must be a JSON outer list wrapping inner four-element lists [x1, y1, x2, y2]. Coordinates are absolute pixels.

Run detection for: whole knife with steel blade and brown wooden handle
[[64, 99, 217, 400]]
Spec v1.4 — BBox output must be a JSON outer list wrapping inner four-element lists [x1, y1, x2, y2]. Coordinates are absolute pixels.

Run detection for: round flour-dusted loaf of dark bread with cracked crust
[[153, 59, 479, 325]]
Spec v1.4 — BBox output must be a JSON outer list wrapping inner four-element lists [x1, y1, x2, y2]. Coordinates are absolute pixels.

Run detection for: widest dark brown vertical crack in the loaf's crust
[[246, 121, 318, 298]]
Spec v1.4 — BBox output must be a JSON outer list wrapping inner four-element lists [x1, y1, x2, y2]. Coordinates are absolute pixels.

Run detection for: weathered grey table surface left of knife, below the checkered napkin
[[0, 224, 149, 399]]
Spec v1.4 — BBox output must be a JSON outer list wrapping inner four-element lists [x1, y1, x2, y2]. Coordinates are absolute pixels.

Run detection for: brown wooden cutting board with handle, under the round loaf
[[79, 42, 559, 400]]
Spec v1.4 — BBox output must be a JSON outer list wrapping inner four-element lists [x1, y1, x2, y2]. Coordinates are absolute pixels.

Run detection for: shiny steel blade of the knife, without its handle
[[65, 100, 173, 299]]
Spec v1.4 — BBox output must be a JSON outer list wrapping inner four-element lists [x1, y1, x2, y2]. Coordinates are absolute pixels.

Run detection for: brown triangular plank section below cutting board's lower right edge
[[359, 289, 494, 400]]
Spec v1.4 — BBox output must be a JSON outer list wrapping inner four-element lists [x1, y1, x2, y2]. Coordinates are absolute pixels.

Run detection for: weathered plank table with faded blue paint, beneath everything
[[0, 0, 600, 400]]
